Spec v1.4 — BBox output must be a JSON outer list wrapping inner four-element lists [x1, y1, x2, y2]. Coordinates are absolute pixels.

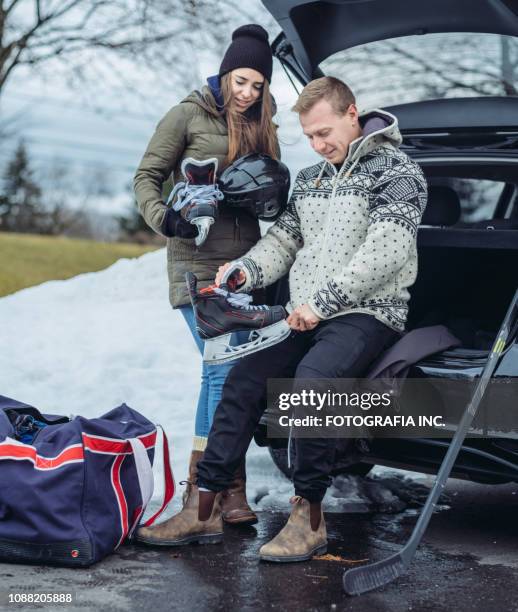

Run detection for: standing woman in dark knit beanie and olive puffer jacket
[[134, 24, 279, 524]]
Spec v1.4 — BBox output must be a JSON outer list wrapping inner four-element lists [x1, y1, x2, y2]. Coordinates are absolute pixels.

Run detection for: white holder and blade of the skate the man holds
[[203, 319, 291, 364]]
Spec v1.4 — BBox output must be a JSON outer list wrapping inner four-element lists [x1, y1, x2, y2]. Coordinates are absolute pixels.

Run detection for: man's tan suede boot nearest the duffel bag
[[136, 483, 223, 546]]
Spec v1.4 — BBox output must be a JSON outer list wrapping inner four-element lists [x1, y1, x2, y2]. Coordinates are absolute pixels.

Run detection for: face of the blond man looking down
[[299, 99, 361, 164]]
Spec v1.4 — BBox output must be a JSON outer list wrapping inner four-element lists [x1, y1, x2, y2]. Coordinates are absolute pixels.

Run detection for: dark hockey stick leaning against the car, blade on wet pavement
[[343, 289, 518, 595]]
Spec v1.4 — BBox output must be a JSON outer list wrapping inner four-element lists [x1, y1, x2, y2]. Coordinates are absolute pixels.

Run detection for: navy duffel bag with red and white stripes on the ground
[[0, 395, 174, 566]]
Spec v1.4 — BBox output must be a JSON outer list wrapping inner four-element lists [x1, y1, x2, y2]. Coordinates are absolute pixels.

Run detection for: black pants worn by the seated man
[[198, 314, 399, 502]]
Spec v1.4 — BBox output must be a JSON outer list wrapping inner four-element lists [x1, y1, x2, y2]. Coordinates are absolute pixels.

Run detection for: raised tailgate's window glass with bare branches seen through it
[[320, 32, 518, 110]]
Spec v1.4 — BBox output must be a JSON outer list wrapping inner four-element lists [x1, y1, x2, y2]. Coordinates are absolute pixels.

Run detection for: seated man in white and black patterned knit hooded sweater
[[138, 77, 426, 562]]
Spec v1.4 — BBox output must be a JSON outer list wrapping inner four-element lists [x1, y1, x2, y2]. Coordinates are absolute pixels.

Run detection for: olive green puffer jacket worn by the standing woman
[[134, 87, 260, 307]]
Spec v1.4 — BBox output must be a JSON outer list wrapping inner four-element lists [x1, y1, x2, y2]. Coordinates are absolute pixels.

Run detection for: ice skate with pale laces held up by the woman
[[167, 157, 223, 246]]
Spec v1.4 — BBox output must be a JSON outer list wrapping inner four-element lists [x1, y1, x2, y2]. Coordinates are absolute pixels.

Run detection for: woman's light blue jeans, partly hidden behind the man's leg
[[178, 304, 249, 450]]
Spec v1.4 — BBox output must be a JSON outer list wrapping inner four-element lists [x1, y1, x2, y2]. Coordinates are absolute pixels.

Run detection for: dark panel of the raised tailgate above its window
[[262, 0, 518, 78]]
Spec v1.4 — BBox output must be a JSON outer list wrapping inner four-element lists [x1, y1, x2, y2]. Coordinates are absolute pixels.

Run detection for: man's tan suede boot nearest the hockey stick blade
[[259, 495, 327, 563]]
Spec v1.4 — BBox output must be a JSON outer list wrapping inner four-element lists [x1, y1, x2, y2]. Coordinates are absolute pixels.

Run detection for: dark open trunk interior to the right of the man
[[408, 227, 518, 356]]
